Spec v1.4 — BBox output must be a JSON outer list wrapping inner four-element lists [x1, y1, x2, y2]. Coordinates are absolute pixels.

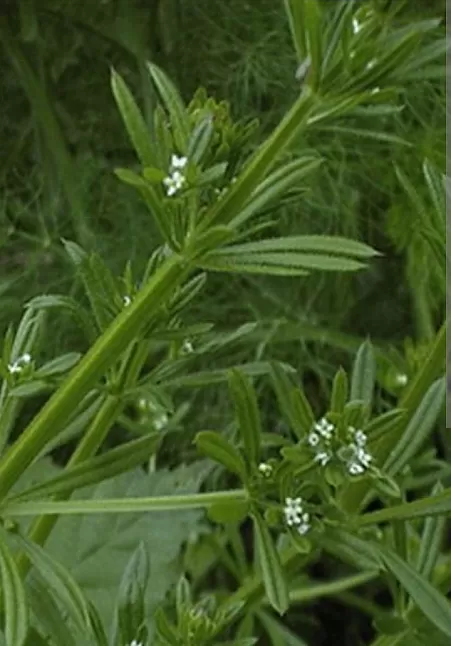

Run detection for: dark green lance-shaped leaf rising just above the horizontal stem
[[9, 433, 162, 500]]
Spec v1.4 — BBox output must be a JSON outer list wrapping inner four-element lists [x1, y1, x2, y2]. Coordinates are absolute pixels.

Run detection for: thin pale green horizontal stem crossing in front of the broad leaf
[[1, 489, 248, 517]]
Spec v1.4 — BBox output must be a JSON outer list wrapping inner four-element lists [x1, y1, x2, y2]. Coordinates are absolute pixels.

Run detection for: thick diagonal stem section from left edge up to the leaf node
[[0, 255, 189, 499]]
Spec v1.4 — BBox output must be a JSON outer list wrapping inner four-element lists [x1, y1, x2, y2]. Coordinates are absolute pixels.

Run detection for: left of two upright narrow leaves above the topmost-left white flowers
[[111, 70, 154, 166]]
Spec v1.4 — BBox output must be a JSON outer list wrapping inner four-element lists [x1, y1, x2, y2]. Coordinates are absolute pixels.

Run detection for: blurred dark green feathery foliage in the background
[[0, 0, 451, 643]]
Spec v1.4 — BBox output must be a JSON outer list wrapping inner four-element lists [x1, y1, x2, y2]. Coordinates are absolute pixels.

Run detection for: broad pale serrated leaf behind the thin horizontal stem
[[42, 463, 207, 626]]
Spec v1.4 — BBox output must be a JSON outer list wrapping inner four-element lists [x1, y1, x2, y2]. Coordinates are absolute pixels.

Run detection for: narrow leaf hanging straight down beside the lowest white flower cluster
[[253, 513, 289, 615]]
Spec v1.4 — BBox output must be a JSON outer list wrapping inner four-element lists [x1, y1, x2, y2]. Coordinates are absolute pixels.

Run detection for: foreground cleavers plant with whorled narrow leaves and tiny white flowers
[[0, 0, 451, 646]]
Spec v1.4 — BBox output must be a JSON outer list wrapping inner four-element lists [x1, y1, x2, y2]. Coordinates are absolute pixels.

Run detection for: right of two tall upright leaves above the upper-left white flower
[[147, 63, 190, 151]]
